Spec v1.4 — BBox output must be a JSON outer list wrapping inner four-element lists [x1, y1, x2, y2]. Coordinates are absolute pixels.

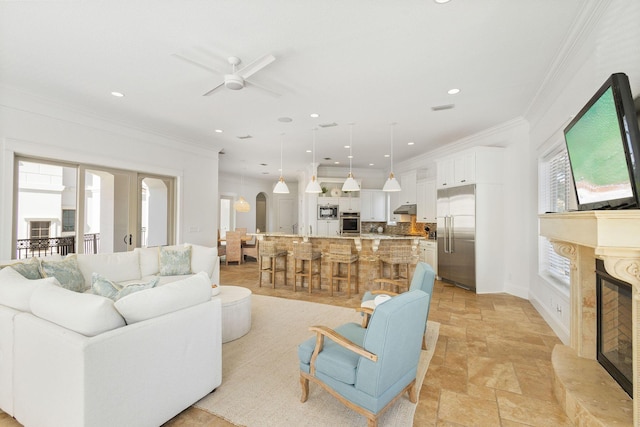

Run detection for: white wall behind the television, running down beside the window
[[526, 0, 640, 343]]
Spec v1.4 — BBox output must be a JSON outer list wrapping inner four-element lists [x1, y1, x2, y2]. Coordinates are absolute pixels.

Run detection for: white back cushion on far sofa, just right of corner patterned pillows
[[78, 251, 142, 289]]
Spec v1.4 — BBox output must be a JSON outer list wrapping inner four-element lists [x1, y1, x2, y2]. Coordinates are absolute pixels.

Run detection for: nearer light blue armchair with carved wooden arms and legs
[[298, 290, 430, 427]]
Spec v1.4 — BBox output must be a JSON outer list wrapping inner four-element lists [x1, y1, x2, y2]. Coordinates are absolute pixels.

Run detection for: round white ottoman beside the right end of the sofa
[[213, 286, 251, 343]]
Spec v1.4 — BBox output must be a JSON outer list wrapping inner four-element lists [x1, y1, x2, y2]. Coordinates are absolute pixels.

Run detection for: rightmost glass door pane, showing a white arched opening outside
[[140, 177, 170, 247]]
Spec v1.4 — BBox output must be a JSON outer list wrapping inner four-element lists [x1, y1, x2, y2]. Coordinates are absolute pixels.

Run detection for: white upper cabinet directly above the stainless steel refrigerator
[[436, 147, 502, 188]]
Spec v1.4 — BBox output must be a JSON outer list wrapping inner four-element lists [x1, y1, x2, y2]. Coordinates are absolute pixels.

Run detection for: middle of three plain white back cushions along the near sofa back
[[31, 284, 125, 337]]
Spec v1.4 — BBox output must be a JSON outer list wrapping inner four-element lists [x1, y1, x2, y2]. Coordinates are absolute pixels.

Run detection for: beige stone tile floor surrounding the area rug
[[0, 262, 572, 427]]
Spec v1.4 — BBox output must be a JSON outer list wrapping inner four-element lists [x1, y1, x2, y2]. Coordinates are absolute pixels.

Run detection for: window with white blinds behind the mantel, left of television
[[540, 146, 573, 287]]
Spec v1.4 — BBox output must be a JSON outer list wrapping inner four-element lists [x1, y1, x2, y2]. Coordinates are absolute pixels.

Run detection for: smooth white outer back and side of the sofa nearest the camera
[[14, 299, 222, 427]]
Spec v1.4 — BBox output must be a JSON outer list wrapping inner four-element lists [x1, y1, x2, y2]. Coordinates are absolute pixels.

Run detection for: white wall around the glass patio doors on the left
[[0, 87, 219, 259]]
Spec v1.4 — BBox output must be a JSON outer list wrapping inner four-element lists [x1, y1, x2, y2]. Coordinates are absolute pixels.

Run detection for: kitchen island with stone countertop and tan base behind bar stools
[[256, 233, 426, 298]]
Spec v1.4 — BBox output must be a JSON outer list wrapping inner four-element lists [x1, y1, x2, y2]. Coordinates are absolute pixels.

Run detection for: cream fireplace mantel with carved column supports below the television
[[539, 210, 640, 426]]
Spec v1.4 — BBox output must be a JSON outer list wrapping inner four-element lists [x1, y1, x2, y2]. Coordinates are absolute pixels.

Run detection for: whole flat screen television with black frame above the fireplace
[[564, 73, 640, 211]]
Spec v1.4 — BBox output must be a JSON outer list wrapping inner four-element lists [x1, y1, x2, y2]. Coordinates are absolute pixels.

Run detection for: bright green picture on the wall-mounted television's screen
[[565, 88, 633, 203]]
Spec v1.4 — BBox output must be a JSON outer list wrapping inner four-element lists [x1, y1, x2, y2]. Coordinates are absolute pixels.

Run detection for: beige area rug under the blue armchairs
[[195, 295, 440, 427]]
